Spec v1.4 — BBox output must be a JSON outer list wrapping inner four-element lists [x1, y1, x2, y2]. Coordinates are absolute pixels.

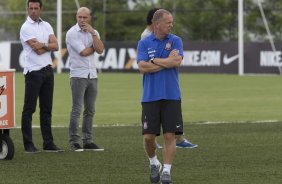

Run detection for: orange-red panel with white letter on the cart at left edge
[[0, 69, 15, 129]]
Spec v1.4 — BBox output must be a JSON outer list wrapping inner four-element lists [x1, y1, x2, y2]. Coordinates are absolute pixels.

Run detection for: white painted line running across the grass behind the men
[[14, 120, 280, 128]]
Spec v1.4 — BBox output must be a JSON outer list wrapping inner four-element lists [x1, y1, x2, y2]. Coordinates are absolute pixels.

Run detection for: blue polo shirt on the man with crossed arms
[[137, 34, 183, 102]]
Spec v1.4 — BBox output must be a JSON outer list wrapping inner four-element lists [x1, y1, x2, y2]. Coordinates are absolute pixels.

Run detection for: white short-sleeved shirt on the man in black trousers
[[20, 16, 54, 74]]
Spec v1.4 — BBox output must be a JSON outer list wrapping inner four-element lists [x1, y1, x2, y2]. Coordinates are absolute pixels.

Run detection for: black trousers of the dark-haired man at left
[[21, 65, 54, 148]]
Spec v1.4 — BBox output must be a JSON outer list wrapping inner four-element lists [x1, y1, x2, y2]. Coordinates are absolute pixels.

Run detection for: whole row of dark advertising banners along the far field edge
[[3, 42, 282, 74]]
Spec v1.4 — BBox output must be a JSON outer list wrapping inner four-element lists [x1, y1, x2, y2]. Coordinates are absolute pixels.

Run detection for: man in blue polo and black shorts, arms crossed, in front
[[137, 9, 183, 184]]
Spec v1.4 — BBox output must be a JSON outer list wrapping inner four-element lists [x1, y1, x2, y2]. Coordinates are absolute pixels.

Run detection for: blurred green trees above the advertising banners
[[0, 0, 282, 42]]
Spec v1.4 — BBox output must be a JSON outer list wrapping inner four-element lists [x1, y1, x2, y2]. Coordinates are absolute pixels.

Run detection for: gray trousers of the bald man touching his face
[[69, 77, 98, 144]]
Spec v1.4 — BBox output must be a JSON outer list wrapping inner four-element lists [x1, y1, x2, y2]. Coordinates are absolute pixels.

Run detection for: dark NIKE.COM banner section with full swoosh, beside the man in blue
[[181, 42, 238, 74]]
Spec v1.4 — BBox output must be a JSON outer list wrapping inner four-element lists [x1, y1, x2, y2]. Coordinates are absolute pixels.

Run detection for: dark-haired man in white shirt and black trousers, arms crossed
[[20, 0, 64, 153]]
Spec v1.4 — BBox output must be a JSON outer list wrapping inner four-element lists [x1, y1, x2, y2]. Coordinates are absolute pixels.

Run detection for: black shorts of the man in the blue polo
[[141, 100, 183, 136]]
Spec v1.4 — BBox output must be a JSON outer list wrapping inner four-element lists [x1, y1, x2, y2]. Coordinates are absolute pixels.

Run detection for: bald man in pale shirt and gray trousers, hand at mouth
[[66, 7, 104, 151]]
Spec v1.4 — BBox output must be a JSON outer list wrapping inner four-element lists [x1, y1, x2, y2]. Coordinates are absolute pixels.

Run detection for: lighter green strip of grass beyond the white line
[[16, 73, 282, 126]]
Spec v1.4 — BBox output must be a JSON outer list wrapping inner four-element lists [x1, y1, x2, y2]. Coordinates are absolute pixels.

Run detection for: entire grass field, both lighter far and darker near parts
[[0, 73, 282, 184]]
